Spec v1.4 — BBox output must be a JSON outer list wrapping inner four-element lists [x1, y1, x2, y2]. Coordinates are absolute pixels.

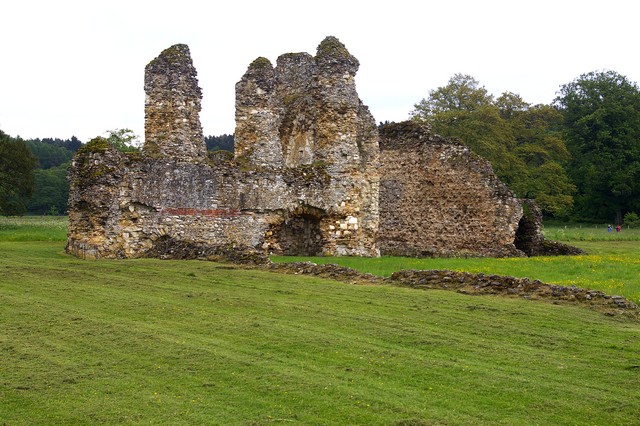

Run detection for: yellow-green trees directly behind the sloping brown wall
[[412, 74, 575, 217]]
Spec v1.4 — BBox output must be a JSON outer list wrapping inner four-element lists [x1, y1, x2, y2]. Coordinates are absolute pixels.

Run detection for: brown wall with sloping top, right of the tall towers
[[378, 121, 523, 257]]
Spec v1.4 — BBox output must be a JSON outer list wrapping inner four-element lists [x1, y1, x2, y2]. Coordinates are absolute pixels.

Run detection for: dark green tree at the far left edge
[[0, 130, 36, 216]]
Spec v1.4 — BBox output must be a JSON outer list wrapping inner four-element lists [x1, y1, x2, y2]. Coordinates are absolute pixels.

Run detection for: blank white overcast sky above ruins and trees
[[0, 0, 640, 142]]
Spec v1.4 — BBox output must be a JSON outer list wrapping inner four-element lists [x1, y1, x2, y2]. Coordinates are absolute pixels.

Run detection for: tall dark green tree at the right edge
[[555, 71, 640, 224]]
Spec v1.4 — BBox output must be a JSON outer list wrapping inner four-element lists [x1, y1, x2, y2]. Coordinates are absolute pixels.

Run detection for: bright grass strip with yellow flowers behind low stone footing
[[271, 225, 640, 304]]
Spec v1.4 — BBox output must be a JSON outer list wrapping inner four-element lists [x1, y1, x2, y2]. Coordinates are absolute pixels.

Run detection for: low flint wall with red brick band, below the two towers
[[68, 140, 372, 258]]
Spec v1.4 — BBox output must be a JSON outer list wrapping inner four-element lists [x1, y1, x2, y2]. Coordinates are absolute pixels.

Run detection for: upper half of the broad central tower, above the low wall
[[235, 37, 378, 172]]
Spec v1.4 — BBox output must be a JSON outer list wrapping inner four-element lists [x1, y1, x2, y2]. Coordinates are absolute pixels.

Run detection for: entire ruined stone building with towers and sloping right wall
[[66, 37, 576, 261]]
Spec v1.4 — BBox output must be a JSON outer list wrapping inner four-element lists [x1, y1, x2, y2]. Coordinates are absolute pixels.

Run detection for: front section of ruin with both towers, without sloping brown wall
[[67, 38, 378, 258]]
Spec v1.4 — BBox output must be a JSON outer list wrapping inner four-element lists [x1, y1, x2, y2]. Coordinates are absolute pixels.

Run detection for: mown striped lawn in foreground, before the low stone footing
[[0, 219, 640, 426]]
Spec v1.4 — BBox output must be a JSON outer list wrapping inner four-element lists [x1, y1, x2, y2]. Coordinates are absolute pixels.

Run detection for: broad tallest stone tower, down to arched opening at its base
[[235, 37, 379, 256]]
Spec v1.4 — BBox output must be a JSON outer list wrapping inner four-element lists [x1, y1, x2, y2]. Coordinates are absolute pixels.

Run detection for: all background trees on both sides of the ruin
[[0, 71, 640, 224]]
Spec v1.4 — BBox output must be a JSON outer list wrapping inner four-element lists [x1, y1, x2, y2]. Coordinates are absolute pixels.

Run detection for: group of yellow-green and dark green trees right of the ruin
[[411, 71, 640, 224]]
